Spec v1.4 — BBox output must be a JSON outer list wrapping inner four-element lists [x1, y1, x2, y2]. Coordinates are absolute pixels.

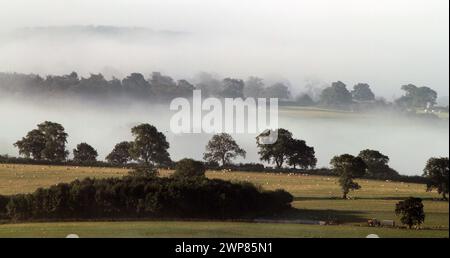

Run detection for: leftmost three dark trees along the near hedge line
[[14, 121, 171, 166]]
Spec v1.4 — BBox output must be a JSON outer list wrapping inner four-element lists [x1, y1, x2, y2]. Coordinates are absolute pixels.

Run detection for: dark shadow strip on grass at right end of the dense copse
[[267, 208, 367, 223]]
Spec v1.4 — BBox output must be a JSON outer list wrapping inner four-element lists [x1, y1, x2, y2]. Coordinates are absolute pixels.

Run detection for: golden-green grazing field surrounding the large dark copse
[[0, 164, 449, 237]]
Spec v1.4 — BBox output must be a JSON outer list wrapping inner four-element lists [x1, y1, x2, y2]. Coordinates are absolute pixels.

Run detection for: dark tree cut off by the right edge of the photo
[[424, 158, 449, 200]]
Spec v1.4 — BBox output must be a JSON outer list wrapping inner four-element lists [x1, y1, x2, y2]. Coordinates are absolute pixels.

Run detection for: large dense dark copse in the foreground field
[[0, 177, 293, 220]]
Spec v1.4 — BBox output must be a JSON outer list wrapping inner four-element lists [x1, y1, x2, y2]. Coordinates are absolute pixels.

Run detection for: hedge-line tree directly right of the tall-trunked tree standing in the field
[[358, 149, 399, 179]]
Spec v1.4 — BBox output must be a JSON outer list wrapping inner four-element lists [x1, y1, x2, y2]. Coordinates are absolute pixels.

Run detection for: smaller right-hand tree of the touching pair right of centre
[[288, 139, 317, 169]]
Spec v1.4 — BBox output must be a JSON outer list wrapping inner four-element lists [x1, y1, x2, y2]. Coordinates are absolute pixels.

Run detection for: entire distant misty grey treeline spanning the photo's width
[[0, 72, 437, 108]]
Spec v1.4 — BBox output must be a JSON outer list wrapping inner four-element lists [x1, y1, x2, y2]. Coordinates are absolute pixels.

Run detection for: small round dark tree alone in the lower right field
[[395, 197, 425, 229]]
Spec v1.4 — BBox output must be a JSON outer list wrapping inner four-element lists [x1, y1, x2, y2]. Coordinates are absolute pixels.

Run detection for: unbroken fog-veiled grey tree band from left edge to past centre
[[0, 72, 291, 101]]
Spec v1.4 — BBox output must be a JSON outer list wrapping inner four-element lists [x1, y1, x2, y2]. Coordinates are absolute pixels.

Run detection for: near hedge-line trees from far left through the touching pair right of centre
[[14, 121, 317, 169]]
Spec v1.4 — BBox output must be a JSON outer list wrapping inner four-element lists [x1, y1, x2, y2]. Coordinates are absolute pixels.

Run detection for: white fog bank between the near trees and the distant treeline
[[0, 99, 449, 175]]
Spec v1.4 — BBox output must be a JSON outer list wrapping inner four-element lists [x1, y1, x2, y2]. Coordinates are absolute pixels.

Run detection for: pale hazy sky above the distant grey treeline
[[0, 0, 449, 98]]
